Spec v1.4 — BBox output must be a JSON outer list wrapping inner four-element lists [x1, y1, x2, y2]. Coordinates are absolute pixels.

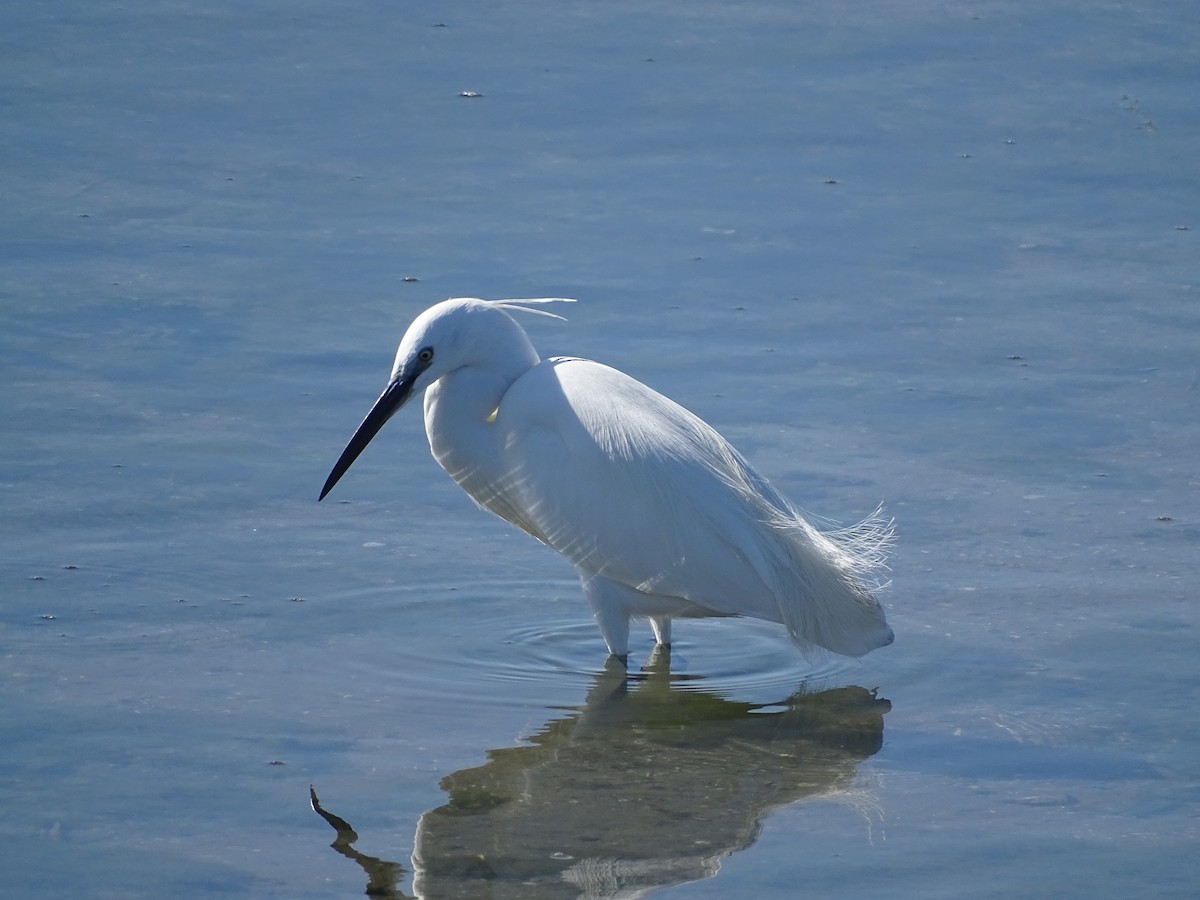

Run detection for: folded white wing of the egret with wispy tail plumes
[[488, 359, 892, 656]]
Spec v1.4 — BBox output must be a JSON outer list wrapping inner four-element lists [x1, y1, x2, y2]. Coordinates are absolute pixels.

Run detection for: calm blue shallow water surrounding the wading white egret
[[0, 2, 1200, 898]]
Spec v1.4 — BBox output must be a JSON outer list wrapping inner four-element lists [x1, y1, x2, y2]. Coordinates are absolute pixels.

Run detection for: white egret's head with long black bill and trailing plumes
[[320, 298, 571, 499]]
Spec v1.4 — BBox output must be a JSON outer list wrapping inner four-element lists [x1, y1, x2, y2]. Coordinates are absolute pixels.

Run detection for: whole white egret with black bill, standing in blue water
[[320, 299, 893, 659]]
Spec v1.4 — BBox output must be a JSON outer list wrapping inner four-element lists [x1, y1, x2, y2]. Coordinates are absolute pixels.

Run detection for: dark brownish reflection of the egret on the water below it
[[314, 654, 892, 898]]
